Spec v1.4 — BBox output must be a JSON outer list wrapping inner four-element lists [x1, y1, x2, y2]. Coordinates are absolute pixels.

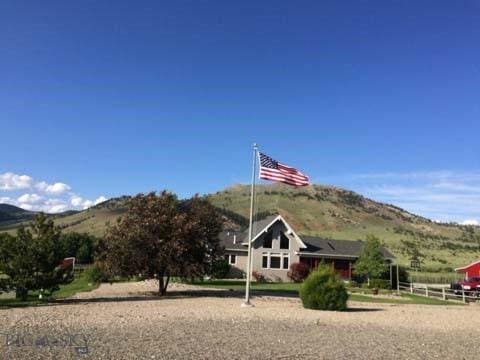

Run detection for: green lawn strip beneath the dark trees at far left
[[0, 273, 100, 308]]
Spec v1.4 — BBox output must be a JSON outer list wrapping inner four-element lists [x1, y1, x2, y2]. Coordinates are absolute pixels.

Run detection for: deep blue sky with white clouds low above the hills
[[0, 0, 480, 222]]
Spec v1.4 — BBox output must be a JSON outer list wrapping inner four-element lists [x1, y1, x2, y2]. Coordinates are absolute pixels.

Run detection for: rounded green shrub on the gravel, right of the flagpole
[[300, 265, 348, 311]]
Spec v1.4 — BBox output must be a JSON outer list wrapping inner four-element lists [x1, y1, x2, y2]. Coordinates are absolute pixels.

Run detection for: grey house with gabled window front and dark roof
[[220, 215, 394, 281]]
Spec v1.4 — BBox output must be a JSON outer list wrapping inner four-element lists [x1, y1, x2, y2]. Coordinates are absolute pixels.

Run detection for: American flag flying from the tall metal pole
[[259, 153, 308, 186]]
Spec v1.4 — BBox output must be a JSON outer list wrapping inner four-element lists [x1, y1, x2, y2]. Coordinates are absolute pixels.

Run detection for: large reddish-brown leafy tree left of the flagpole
[[98, 191, 222, 295]]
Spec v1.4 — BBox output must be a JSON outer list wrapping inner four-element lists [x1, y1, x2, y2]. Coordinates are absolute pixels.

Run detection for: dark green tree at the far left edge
[[0, 214, 66, 300]]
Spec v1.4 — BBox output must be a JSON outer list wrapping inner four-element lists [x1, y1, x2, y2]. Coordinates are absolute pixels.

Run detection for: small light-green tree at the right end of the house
[[354, 235, 385, 285]]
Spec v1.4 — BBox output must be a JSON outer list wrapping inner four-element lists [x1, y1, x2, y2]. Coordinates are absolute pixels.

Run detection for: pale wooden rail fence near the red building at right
[[398, 282, 480, 303]]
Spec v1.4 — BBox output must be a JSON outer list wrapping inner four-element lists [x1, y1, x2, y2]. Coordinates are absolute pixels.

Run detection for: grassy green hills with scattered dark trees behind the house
[[0, 185, 480, 269]]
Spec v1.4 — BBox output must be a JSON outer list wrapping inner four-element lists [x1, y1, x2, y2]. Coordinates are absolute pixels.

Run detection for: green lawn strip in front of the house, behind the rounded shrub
[[193, 280, 461, 305]]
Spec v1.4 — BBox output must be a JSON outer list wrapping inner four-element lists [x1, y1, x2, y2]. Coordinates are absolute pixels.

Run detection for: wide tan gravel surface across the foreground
[[0, 282, 480, 359]]
